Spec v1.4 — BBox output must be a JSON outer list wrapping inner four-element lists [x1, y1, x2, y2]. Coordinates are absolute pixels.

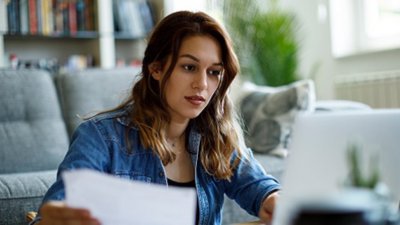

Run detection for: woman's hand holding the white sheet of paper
[[38, 201, 100, 225]]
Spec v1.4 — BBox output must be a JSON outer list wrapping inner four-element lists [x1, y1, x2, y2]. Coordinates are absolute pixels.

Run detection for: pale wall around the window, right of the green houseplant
[[280, 0, 400, 99]]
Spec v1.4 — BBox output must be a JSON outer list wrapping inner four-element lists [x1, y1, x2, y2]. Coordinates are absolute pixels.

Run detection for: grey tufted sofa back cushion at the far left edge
[[0, 69, 69, 174]]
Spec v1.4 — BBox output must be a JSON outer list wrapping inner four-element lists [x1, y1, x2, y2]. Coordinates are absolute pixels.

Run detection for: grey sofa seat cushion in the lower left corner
[[0, 170, 57, 224]]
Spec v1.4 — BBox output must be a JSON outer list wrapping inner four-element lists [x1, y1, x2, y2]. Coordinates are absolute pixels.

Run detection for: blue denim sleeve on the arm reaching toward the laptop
[[224, 149, 281, 216]]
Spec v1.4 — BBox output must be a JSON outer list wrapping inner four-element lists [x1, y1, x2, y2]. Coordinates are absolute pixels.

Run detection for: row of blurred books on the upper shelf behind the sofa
[[0, 0, 155, 38]]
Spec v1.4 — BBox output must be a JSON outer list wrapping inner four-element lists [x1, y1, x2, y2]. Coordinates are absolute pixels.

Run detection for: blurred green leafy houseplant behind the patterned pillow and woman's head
[[224, 0, 299, 86]]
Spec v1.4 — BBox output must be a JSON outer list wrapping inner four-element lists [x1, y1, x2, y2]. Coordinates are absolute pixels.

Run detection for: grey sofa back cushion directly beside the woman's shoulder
[[56, 67, 140, 135]]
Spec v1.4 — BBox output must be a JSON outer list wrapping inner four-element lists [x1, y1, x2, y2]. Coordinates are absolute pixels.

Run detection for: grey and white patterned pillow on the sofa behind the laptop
[[238, 80, 315, 157]]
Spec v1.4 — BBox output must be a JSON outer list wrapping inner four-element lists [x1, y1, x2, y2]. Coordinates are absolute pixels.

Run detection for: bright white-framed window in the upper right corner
[[330, 0, 400, 57]]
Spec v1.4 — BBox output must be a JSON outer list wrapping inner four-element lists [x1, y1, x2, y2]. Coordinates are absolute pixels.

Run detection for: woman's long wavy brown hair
[[114, 11, 244, 179]]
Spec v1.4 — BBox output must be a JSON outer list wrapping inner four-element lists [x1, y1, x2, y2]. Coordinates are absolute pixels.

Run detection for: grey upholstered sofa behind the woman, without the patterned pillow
[[0, 68, 372, 225]]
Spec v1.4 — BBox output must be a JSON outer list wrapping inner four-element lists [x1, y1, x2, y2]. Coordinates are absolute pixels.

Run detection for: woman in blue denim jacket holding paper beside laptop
[[32, 11, 280, 225]]
